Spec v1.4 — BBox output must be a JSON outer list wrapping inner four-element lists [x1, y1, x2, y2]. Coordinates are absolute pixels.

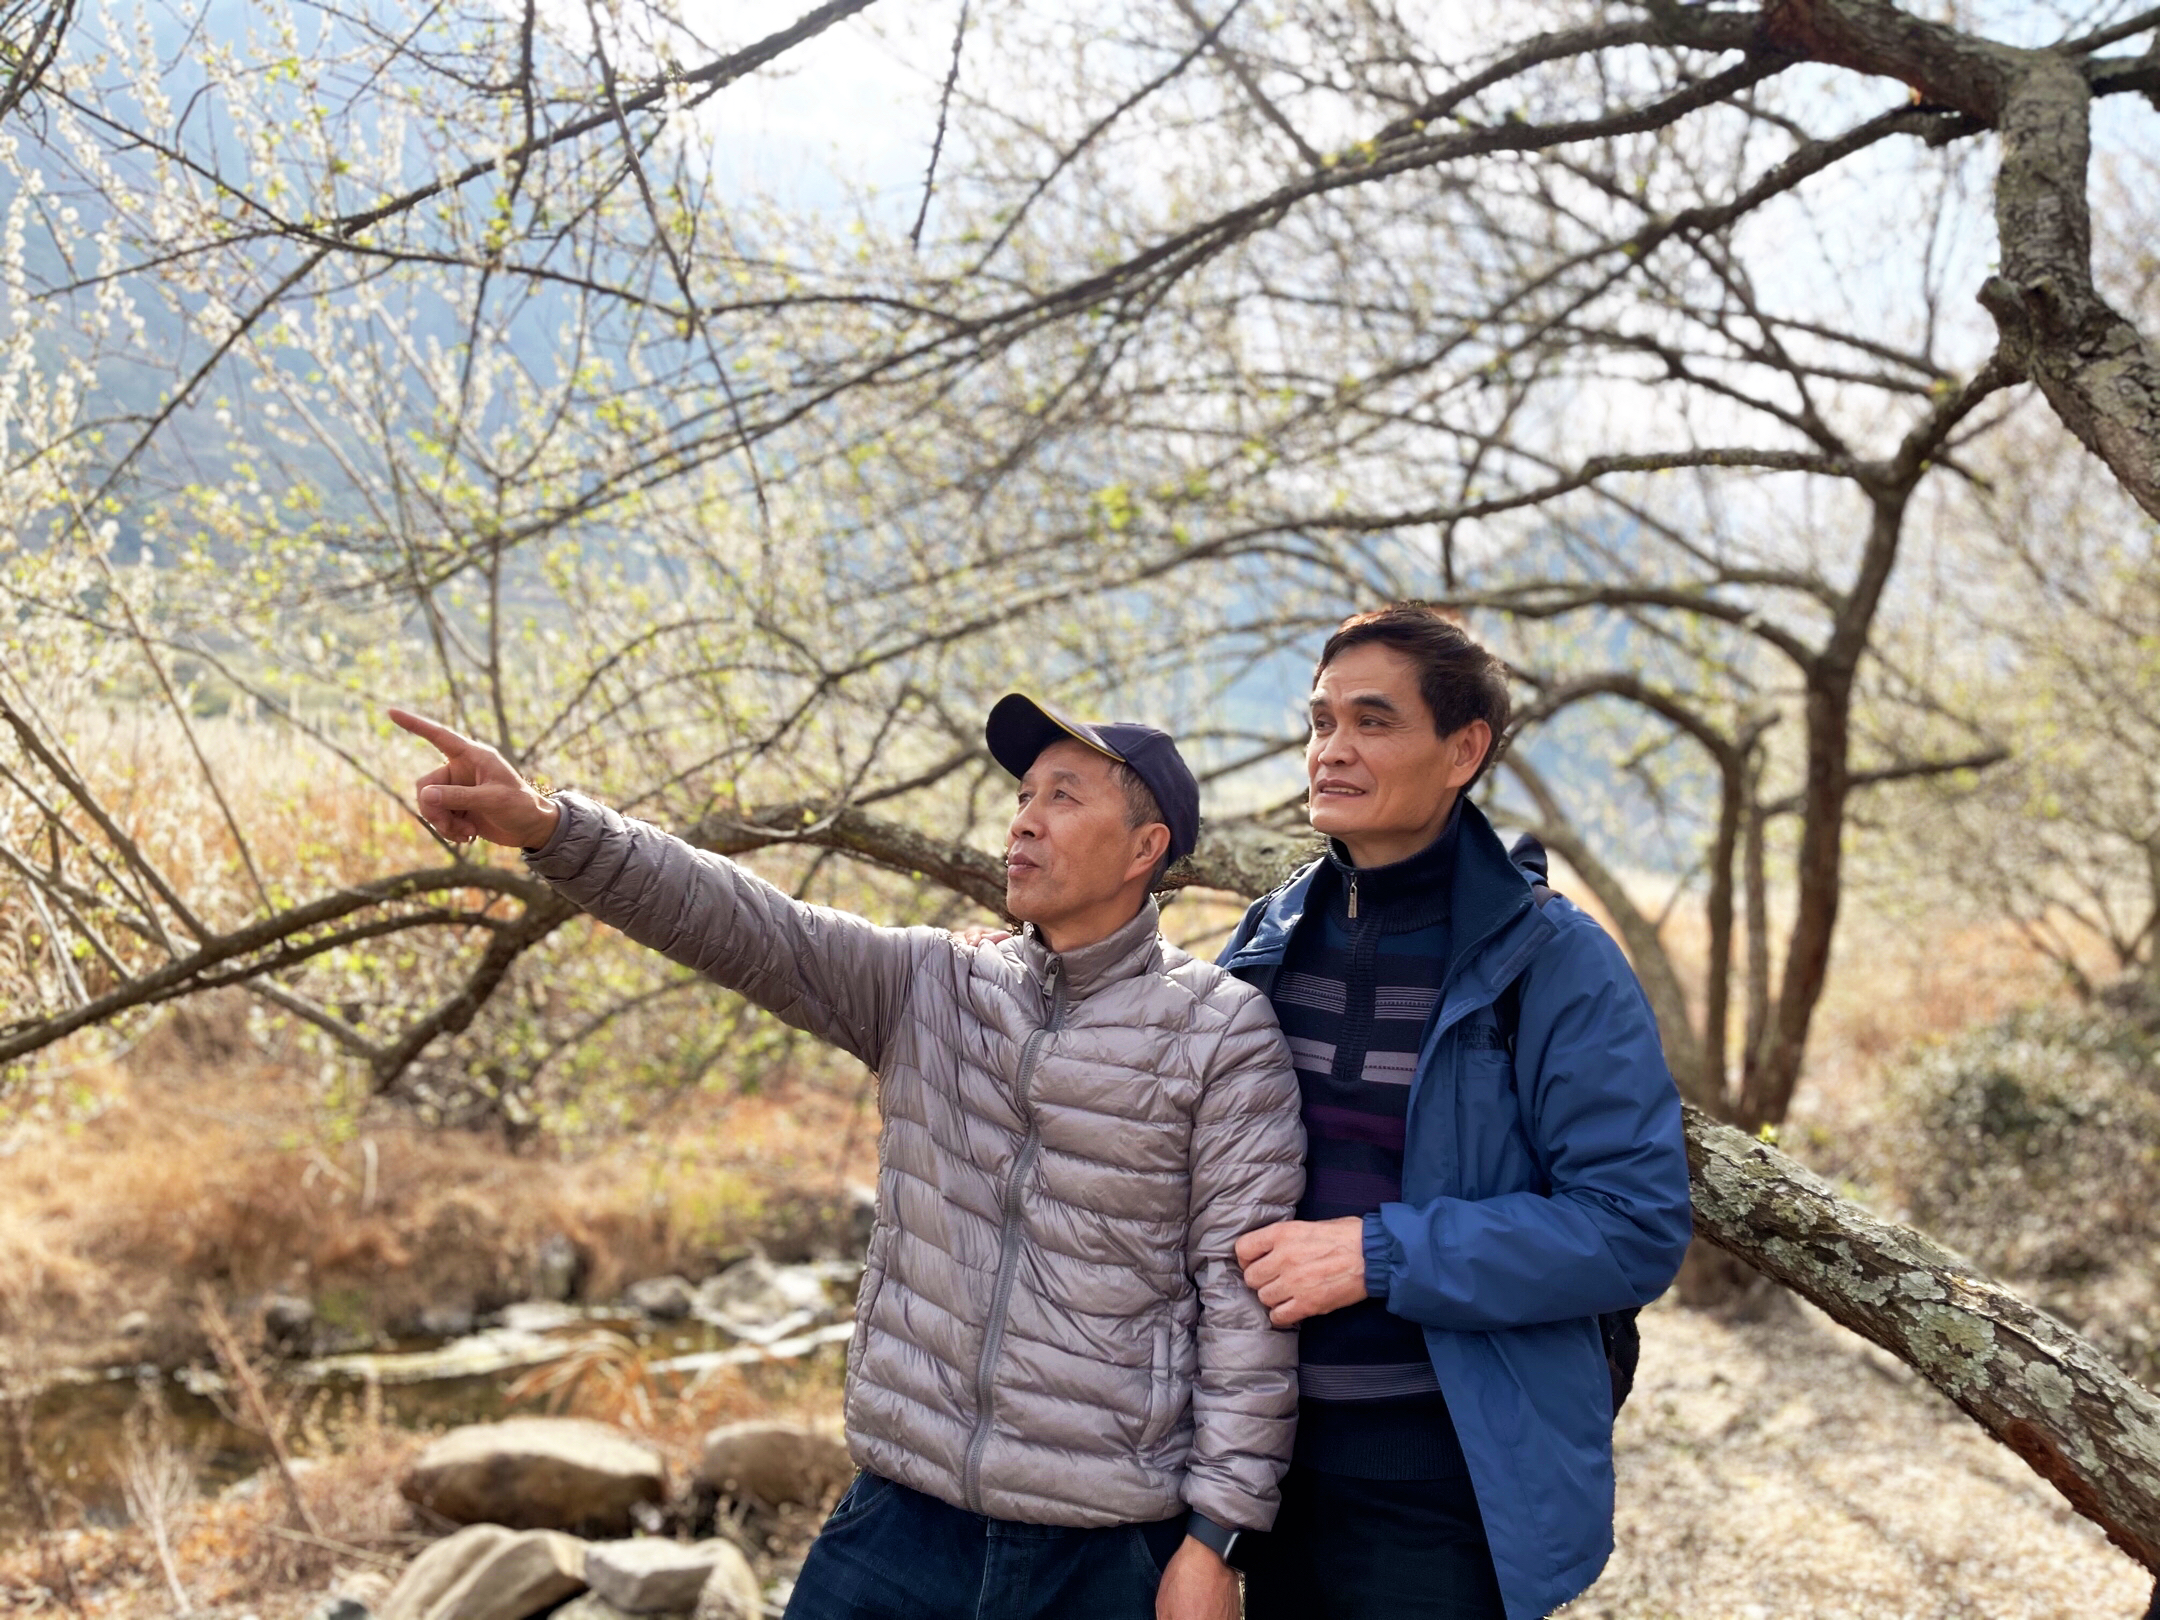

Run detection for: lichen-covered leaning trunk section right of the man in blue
[[1687, 1108, 2160, 1572]]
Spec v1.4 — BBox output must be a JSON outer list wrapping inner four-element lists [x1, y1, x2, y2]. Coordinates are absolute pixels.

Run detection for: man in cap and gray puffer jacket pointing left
[[391, 693, 1305, 1620]]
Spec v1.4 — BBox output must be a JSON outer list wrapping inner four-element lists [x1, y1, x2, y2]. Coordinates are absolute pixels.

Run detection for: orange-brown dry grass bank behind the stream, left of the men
[[0, 1010, 875, 1365]]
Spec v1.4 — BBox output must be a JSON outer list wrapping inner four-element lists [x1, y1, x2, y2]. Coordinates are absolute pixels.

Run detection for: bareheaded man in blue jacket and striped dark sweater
[[1220, 605, 1689, 1620]]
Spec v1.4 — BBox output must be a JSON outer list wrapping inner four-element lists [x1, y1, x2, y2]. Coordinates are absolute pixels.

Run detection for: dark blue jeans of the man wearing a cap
[[786, 1473, 1186, 1620]]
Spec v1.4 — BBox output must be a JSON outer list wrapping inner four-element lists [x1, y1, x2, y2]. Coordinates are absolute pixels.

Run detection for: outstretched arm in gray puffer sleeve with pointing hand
[[391, 708, 920, 1067]]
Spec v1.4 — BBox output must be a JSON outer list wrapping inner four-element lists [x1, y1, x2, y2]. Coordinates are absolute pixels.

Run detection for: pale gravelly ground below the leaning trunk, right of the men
[[1560, 1294, 2154, 1620]]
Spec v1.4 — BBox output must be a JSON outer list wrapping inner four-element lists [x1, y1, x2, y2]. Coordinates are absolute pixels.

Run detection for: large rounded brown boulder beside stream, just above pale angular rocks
[[397, 1417, 667, 1536]]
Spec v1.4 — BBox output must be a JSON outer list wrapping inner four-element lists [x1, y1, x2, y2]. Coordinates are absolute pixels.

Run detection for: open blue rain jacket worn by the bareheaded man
[[1220, 804, 1691, 1620]]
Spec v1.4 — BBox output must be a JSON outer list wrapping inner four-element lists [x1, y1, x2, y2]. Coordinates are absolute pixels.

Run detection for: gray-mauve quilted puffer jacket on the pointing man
[[527, 793, 1305, 1529]]
